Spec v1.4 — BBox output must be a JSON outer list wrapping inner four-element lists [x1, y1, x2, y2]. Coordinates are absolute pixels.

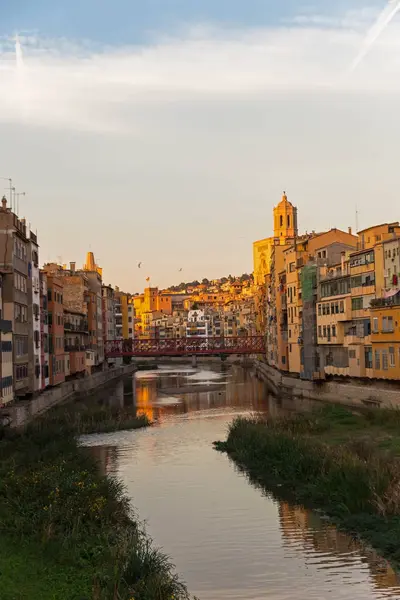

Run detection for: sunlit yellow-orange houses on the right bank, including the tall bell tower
[[254, 194, 400, 380]]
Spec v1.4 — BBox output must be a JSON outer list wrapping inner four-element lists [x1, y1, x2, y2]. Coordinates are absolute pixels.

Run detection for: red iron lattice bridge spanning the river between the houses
[[104, 336, 265, 358]]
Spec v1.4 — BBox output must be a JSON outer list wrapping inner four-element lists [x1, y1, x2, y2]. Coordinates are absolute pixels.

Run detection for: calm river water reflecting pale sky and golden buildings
[[84, 365, 400, 600]]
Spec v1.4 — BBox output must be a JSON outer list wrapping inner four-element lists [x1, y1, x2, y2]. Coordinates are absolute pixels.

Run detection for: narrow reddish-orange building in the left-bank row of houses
[[47, 275, 65, 385]]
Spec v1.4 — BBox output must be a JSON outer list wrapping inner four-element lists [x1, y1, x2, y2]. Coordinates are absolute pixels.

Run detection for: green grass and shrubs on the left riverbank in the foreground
[[0, 407, 194, 600]]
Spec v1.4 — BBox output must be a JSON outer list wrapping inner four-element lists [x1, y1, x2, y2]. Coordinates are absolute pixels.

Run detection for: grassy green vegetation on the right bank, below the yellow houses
[[215, 406, 400, 565]]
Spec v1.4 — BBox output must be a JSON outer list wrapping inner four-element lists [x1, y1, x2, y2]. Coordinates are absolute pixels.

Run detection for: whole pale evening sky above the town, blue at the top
[[0, 0, 400, 292]]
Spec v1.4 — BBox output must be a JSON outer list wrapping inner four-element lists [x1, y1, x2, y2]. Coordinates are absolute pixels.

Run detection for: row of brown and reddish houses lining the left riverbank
[[0, 198, 134, 405]]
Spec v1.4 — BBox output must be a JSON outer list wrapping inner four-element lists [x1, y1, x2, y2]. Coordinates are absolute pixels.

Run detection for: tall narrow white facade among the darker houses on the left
[[28, 231, 42, 394]]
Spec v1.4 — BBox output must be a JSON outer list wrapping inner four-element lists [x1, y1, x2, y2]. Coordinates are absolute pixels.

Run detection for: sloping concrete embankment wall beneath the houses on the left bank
[[1, 364, 137, 427]]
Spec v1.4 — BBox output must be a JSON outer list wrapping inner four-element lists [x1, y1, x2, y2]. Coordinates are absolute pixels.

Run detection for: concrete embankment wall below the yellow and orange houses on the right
[[254, 360, 400, 408]]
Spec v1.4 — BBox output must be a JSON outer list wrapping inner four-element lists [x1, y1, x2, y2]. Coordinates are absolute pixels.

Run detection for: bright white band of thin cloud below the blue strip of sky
[[0, 11, 400, 132]]
